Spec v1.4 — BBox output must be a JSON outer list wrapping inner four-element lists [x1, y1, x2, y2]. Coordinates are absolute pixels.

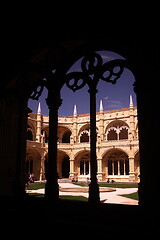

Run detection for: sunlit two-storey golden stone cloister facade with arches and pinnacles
[[26, 96, 140, 182]]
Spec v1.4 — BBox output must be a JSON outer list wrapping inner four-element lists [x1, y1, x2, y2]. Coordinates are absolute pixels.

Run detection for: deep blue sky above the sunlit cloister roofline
[[28, 51, 137, 116]]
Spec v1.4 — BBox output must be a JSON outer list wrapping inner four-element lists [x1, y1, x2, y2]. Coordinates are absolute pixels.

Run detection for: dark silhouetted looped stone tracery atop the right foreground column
[[66, 52, 126, 92]]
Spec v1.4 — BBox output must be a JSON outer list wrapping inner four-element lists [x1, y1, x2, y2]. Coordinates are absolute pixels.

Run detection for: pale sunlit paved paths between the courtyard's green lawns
[[27, 182, 138, 205]]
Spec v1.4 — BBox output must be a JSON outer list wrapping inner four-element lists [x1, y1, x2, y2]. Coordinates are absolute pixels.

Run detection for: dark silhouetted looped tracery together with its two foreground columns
[[21, 51, 134, 202]]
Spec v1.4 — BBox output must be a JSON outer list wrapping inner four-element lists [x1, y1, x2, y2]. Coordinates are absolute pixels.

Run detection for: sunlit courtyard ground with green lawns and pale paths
[[26, 180, 138, 205]]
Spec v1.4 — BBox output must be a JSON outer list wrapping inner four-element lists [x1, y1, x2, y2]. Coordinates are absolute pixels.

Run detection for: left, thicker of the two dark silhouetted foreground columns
[[45, 88, 62, 201]]
